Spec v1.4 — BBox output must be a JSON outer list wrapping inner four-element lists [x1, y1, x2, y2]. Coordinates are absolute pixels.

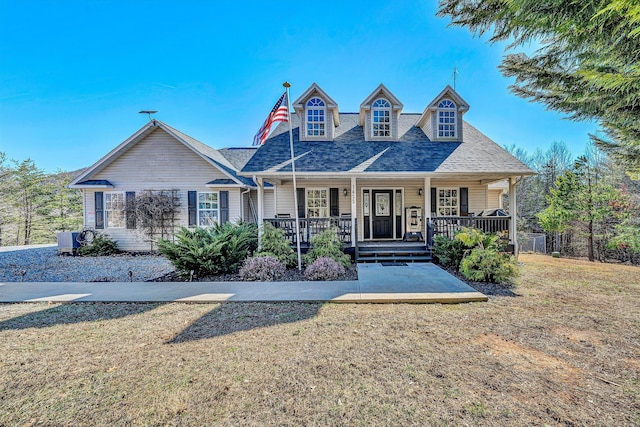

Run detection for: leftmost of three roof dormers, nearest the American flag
[[293, 83, 340, 141]]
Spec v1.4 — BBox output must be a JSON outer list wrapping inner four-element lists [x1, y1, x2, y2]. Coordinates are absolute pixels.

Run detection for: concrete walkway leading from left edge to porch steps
[[0, 263, 487, 303]]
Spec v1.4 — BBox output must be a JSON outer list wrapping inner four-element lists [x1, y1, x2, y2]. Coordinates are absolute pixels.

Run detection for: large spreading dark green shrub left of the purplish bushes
[[158, 222, 258, 277]]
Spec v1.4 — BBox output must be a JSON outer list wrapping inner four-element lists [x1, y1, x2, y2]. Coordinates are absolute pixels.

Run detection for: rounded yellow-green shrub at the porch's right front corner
[[460, 247, 519, 283]]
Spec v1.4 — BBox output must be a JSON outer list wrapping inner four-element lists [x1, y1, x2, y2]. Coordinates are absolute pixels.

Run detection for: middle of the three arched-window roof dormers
[[360, 84, 403, 141]]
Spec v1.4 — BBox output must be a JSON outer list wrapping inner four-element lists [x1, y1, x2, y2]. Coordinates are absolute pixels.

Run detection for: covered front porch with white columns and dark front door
[[257, 176, 517, 258]]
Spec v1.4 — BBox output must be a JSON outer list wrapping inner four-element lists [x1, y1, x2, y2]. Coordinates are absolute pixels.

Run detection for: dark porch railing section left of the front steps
[[264, 217, 352, 246]]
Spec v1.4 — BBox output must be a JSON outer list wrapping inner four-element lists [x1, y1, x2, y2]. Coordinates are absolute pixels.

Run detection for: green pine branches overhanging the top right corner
[[438, 0, 640, 172]]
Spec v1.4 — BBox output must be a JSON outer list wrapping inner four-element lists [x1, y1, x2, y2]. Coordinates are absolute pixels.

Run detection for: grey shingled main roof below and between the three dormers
[[240, 113, 533, 175]]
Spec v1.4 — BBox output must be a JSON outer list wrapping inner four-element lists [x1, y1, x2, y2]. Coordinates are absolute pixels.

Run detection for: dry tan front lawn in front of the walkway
[[0, 255, 640, 426]]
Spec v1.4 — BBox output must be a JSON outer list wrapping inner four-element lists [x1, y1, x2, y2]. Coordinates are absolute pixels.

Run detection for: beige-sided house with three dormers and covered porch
[[71, 83, 533, 258]]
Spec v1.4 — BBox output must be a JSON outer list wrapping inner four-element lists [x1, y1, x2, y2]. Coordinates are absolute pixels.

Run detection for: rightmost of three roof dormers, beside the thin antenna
[[416, 85, 469, 141]]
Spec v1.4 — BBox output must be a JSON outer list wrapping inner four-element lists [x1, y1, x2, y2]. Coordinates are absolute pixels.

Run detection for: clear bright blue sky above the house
[[0, 0, 596, 172]]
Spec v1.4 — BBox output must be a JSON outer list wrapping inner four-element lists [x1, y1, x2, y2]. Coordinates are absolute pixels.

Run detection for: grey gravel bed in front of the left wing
[[0, 247, 173, 282]]
